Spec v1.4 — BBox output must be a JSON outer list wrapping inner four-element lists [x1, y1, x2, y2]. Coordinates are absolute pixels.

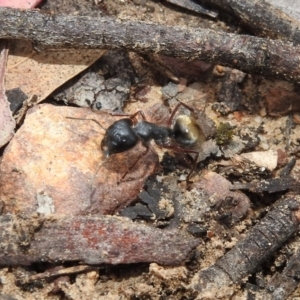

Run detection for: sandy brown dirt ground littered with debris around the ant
[[0, 0, 300, 300]]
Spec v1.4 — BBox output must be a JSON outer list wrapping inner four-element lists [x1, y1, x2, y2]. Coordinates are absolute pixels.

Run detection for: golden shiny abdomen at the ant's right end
[[173, 115, 205, 148]]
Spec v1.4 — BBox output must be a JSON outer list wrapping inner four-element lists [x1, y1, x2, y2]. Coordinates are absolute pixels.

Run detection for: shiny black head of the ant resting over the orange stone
[[101, 119, 139, 157]]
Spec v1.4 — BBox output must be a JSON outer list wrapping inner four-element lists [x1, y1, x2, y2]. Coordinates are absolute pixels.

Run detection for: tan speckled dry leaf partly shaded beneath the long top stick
[[6, 41, 105, 103]]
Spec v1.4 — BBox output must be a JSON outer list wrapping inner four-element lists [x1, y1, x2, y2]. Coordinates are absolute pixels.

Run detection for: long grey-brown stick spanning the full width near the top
[[0, 8, 300, 82]]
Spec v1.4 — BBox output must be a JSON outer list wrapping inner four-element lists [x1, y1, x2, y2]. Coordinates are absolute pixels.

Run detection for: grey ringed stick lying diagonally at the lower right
[[190, 196, 300, 292]]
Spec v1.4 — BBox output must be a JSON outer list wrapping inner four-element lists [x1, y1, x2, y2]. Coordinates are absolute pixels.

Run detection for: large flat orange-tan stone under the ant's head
[[0, 104, 158, 215]]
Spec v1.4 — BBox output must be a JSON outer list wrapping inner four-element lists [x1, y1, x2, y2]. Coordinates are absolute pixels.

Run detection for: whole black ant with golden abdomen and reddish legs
[[101, 102, 205, 183]]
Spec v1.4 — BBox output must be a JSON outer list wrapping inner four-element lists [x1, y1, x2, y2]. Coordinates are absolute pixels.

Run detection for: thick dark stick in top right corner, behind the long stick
[[198, 0, 300, 45]]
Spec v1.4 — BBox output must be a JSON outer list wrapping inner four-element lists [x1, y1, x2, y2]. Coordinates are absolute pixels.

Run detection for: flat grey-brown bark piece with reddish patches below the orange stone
[[0, 215, 199, 266]]
